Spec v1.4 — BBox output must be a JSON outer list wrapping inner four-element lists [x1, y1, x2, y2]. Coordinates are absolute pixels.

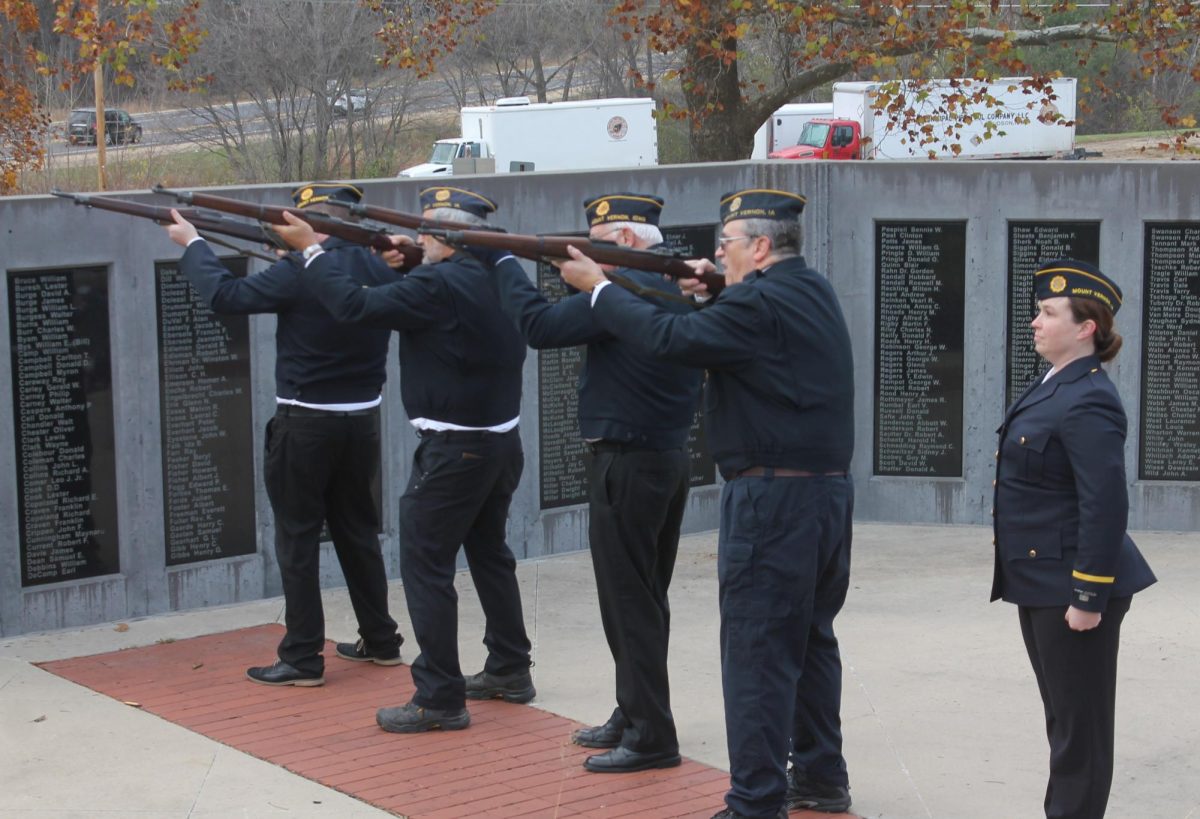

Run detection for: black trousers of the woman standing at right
[[1018, 597, 1132, 819]]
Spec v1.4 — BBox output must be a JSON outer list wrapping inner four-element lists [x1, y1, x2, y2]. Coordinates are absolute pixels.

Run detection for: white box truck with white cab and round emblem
[[397, 97, 659, 177]]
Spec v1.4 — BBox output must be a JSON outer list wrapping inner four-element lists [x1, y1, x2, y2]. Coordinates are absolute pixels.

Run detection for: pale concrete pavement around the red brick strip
[[0, 524, 1200, 819]]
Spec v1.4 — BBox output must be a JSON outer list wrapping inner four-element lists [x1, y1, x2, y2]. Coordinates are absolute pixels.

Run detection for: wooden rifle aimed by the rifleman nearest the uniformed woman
[[421, 226, 725, 295]]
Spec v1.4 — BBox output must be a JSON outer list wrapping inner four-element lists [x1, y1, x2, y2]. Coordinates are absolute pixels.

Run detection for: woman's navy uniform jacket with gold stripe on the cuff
[[991, 355, 1154, 611]]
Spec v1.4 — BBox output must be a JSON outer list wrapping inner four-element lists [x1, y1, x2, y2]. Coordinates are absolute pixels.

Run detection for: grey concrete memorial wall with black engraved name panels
[[0, 161, 1200, 635]]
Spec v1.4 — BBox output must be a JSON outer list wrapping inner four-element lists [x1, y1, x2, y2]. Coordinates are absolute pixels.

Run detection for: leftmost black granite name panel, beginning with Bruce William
[[8, 267, 120, 586]]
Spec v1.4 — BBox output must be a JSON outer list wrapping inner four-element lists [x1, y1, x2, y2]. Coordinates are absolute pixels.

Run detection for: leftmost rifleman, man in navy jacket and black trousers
[[167, 183, 403, 686]]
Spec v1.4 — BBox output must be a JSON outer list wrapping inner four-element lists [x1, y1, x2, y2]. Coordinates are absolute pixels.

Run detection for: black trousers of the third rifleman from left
[[588, 443, 689, 752]]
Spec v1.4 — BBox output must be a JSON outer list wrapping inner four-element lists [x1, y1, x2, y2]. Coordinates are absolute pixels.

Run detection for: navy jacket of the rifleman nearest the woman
[[593, 256, 854, 478]]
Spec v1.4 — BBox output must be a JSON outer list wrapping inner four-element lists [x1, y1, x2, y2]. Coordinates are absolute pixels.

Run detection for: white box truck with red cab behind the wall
[[769, 77, 1075, 160]]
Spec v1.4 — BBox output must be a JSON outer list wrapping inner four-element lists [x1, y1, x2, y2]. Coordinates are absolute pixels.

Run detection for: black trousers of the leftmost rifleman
[[264, 405, 402, 671]]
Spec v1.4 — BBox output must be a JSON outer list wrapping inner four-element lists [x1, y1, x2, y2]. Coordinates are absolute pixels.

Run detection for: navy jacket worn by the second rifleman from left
[[300, 252, 526, 428]]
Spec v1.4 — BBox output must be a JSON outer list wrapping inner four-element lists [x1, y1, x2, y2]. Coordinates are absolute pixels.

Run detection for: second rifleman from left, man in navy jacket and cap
[[280, 186, 535, 734]]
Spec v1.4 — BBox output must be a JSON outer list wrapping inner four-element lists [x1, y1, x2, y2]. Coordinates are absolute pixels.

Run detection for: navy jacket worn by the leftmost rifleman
[[179, 237, 398, 403]]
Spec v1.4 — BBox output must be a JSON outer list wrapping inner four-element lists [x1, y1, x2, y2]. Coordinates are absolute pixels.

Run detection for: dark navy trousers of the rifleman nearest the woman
[[716, 476, 854, 817]]
